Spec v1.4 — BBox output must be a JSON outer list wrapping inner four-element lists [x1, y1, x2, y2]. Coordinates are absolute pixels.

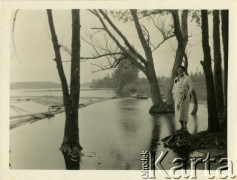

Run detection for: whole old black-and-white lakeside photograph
[[0, 3, 236, 179]]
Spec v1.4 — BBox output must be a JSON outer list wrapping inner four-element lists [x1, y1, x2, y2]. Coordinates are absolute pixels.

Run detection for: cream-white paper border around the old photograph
[[0, 0, 237, 180]]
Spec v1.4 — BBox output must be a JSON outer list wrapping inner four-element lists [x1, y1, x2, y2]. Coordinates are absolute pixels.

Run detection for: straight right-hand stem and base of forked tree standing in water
[[61, 10, 82, 169]]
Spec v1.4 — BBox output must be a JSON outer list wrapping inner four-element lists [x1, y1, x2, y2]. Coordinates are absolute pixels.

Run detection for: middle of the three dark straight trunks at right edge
[[213, 10, 224, 116]]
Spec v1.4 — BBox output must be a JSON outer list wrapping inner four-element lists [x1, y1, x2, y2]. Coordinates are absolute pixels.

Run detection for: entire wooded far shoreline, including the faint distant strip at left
[[10, 69, 207, 100]]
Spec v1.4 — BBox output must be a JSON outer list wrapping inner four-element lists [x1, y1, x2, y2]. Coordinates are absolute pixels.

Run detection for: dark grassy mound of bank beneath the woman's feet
[[162, 131, 228, 169]]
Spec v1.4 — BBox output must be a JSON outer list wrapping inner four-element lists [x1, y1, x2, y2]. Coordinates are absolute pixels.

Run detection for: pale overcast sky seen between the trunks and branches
[[11, 10, 206, 83]]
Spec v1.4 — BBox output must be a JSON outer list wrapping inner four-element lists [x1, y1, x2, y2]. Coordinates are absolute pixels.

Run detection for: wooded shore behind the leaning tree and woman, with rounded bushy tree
[[90, 68, 207, 100]]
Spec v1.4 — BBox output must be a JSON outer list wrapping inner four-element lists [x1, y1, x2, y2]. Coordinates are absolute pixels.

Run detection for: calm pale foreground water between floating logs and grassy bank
[[10, 89, 207, 170]]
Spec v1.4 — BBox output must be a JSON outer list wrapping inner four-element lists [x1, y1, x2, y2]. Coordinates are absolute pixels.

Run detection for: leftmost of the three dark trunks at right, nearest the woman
[[201, 10, 220, 131]]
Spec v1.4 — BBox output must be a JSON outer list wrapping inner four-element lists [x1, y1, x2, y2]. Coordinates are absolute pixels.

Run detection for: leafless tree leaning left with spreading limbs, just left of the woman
[[89, 9, 174, 114]]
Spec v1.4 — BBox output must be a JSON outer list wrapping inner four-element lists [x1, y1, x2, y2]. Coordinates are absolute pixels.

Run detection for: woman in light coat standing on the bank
[[172, 66, 193, 131]]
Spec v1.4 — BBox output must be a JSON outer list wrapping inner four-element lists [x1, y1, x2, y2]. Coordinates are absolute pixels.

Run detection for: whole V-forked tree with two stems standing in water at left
[[47, 10, 82, 169]]
